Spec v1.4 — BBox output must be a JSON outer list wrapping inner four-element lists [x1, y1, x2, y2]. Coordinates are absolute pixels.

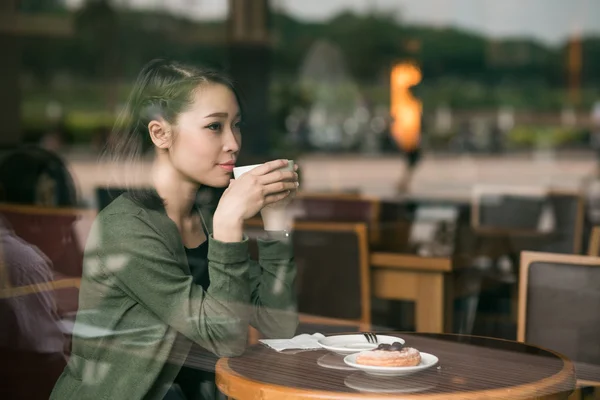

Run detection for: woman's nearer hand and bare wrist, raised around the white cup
[[213, 160, 298, 242]]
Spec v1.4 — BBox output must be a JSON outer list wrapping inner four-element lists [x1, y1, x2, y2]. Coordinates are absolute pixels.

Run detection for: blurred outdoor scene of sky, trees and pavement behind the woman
[[0, 0, 600, 199]]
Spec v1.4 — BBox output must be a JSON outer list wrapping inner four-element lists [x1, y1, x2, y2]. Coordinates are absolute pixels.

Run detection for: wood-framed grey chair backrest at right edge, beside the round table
[[517, 252, 600, 365]]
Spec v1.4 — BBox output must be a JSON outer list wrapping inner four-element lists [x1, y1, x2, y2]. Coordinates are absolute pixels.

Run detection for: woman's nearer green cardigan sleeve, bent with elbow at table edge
[[97, 214, 251, 357]]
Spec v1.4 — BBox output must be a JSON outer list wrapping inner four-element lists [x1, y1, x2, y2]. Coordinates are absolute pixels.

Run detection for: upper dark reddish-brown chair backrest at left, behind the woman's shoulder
[[0, 203, 96, 278]]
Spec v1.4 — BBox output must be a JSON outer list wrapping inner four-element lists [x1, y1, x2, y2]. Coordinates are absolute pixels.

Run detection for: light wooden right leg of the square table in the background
[[415, 272, 444, 333]]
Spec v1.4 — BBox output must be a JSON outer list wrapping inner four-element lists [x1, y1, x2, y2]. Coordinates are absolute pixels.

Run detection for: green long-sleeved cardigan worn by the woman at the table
[[51, 192, 298, 400]]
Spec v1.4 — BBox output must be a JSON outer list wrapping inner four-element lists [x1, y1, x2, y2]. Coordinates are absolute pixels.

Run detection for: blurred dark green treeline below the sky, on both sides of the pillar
[[12, 4, 600, 119]]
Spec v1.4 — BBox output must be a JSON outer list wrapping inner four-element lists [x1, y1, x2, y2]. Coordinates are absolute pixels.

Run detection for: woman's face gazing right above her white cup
[[169, 84, 242, 187]]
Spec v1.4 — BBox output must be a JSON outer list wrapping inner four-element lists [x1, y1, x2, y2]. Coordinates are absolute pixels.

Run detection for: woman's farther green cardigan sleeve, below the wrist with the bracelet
[[250, 239, 298, 338]]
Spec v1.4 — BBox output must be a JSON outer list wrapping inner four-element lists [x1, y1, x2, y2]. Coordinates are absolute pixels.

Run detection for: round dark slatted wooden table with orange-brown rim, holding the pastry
[[216, 332, 575, 400]]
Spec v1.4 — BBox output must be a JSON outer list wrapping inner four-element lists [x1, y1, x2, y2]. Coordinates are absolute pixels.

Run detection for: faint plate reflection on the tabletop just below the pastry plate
[[344, 372, 437, 393]]
